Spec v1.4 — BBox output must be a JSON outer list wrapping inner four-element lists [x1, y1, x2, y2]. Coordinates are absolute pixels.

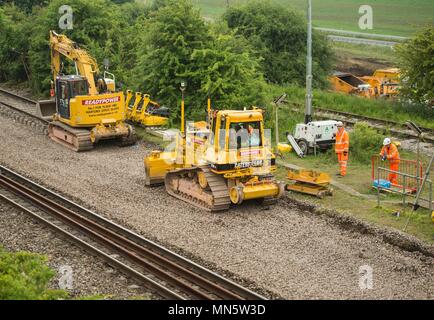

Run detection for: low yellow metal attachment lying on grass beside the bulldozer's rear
[[286, 169, 333, 199]]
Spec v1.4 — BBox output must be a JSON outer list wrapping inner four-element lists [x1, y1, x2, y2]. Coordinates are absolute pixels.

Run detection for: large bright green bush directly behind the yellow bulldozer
[[133, 0, 265, 120]]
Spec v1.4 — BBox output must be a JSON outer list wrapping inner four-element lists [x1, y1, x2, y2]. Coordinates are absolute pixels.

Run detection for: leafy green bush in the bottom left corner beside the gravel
[[0, 247, 67, 300]]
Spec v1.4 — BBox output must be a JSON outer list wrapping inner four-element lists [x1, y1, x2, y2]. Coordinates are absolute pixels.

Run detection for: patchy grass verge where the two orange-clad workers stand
[[276, 152, 434, 243]]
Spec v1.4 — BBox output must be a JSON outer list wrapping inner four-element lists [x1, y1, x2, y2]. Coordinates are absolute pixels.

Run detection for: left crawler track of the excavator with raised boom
[[48, 121, 93, 152]]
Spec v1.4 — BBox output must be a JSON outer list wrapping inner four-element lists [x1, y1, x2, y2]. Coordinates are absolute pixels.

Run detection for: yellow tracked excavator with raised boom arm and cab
[[37, 31, 136, 152]]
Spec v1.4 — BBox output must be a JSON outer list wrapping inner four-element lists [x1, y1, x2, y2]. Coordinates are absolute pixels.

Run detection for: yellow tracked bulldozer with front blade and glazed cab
[[144, 94, 285, 212]]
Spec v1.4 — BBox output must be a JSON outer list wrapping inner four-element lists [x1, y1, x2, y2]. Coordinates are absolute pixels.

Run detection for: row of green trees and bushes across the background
[[0, 0, 433, 116]]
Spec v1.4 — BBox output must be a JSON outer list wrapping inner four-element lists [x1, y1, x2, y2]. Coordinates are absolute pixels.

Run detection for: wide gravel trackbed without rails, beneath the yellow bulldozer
[[0, 117, 434, 299]]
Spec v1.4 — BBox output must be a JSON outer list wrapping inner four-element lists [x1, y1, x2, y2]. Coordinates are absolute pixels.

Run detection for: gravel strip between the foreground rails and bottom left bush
[[0, 202, 152, 299]]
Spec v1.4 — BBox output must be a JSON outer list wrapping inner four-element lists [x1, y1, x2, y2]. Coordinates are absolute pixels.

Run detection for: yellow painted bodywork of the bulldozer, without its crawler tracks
[[144, 110, 283, 204]]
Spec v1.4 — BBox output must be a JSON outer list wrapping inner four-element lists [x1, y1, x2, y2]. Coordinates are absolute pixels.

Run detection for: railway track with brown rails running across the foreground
[[0, 166, 265, 300]]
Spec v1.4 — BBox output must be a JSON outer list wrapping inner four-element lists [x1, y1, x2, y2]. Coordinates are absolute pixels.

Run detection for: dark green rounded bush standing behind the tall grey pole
[[223, 0, 331, 87]]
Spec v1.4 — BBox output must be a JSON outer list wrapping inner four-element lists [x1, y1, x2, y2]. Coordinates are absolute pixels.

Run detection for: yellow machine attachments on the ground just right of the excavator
[[125, 90, 170, 128]]
